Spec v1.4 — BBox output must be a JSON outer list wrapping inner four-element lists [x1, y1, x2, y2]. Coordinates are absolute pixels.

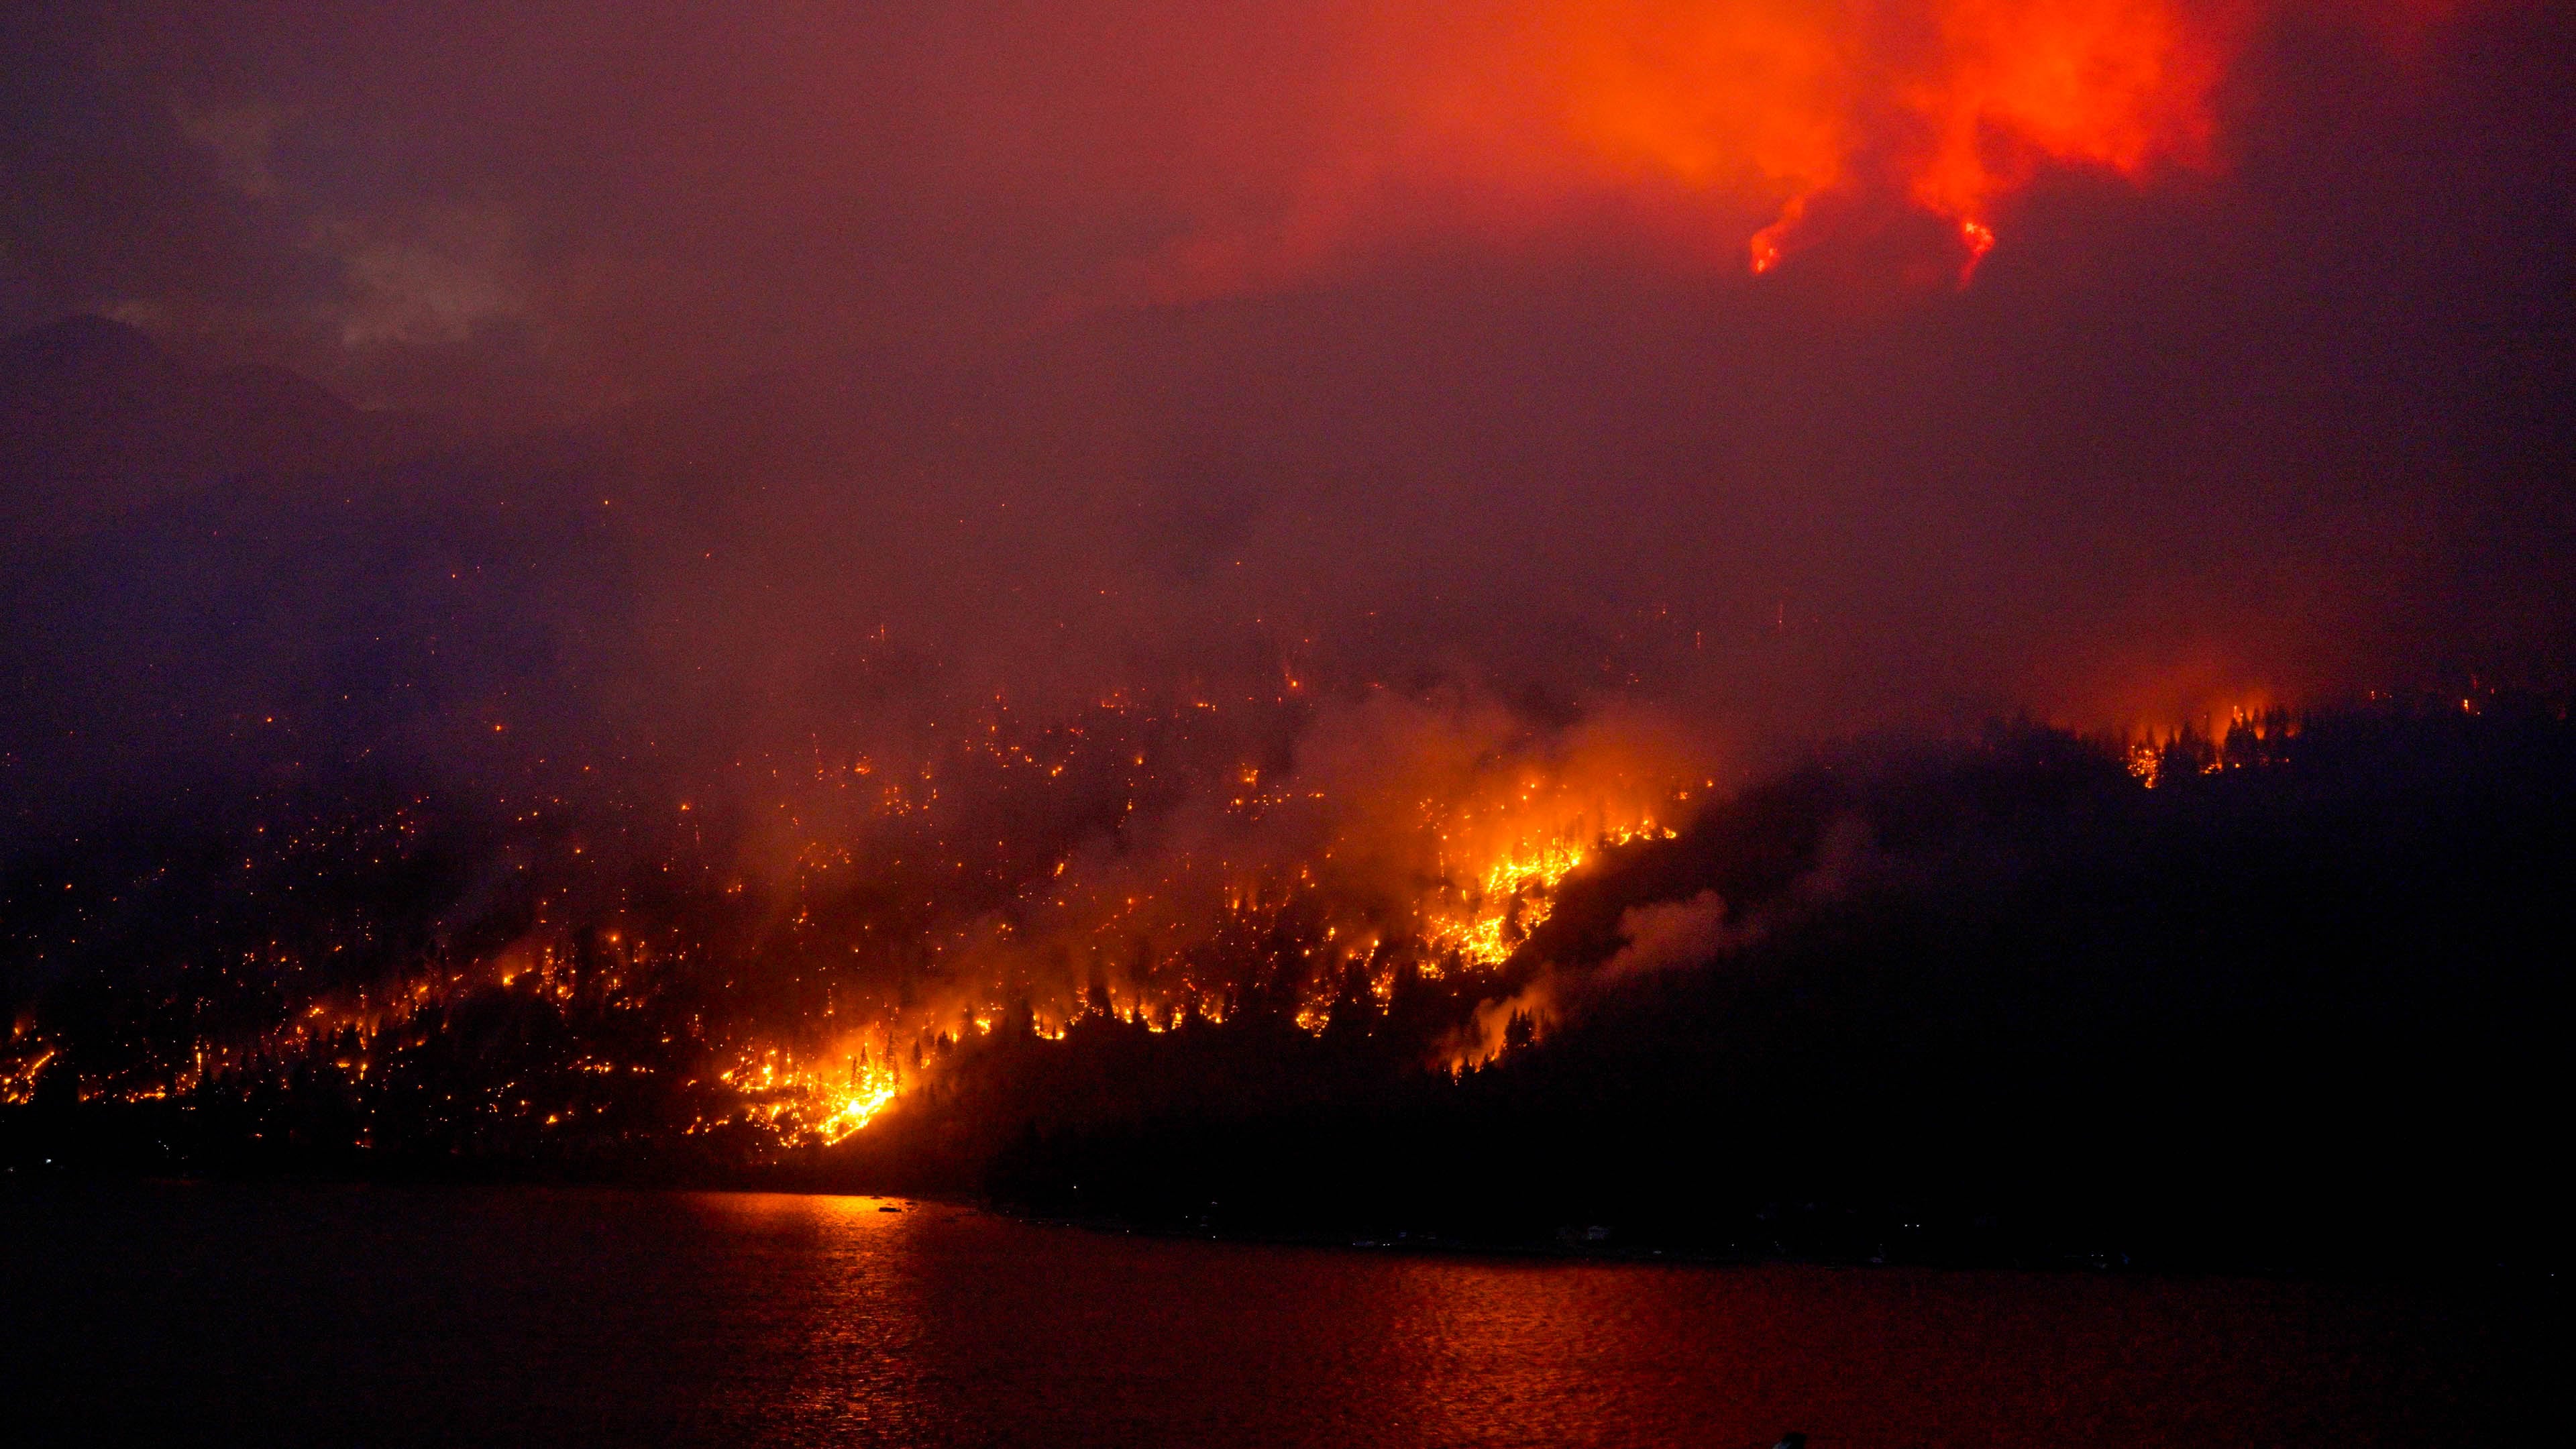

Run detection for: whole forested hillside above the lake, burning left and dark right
[[5, 675, 2576, 1253]]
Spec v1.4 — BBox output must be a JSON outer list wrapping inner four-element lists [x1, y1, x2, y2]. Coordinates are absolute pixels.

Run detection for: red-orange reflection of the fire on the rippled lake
[[675, 1199, 2465, 1449]]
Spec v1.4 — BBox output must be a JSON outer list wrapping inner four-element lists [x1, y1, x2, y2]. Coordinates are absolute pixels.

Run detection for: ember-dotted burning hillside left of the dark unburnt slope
[[10, 691, 1711, 1168]]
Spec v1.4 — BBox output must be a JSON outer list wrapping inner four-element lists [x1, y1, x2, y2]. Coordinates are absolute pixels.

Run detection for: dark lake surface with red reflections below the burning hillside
[[0, 1183, 2535, 1449]]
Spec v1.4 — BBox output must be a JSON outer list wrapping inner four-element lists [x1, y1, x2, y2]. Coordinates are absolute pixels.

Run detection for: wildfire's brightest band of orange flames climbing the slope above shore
[[0, 680, 1700, 1161]]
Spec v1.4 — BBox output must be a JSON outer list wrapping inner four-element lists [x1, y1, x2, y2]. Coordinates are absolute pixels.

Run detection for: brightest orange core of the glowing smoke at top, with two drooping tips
[[1494, 0, 2241, 273]]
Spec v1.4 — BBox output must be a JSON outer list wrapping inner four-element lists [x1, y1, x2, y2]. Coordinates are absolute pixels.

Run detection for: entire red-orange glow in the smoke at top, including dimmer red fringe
[[1118, 0, 2455, 299]]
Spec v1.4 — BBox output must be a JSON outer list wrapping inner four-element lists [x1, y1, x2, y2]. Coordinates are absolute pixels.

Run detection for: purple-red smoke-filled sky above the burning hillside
[[0, 0, 2576, 824]]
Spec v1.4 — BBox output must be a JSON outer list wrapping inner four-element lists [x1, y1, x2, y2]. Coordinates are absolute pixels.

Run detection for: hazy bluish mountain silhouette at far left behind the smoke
[[0, 317, 631, 835]]
